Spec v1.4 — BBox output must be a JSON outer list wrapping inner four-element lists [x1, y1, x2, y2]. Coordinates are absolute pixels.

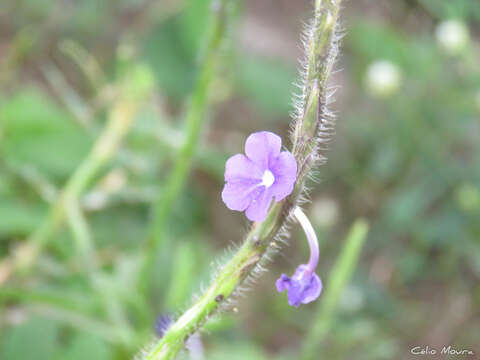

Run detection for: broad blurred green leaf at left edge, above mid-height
[[0, 90, 91, 177]]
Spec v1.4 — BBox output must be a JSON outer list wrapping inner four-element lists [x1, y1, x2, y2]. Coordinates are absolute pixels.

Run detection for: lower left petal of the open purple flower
[[222, 179, 265, 211]]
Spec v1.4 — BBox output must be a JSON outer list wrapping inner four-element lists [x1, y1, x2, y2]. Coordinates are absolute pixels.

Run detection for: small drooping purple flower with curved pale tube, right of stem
[[276, 207, 322, 307]]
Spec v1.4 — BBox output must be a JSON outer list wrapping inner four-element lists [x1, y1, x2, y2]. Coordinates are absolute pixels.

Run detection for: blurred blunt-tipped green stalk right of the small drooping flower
[[300, 219, 368, 360]]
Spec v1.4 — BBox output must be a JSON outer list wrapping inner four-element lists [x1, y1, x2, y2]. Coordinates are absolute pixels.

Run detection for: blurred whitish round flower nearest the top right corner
[[435, 20, 469, 55]]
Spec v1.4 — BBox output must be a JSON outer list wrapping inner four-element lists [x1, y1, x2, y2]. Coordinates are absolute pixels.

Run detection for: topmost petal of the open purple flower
[[245, 131, 282, 170]]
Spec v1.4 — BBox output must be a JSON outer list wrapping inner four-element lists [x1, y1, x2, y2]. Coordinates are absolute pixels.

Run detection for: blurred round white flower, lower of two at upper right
[[365, 60, 402, 97]]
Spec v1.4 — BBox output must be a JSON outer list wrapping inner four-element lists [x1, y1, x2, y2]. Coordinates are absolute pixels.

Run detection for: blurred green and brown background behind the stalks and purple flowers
[[0, 0, 480, 360]]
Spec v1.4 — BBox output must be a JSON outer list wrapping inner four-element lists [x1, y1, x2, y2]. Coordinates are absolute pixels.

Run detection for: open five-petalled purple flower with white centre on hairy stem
[[222, 131, 297, 221]]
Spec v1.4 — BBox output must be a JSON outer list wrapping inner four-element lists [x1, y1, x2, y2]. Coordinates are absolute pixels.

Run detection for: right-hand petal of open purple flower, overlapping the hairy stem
[[270, 151, 297, 201]]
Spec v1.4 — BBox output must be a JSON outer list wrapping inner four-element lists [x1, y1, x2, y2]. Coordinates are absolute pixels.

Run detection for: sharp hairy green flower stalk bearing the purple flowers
[[140, 0, 340, 360]]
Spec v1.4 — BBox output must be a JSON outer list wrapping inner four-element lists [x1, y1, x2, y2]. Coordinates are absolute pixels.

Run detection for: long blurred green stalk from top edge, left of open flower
[[140, 0, 231, 291]]
